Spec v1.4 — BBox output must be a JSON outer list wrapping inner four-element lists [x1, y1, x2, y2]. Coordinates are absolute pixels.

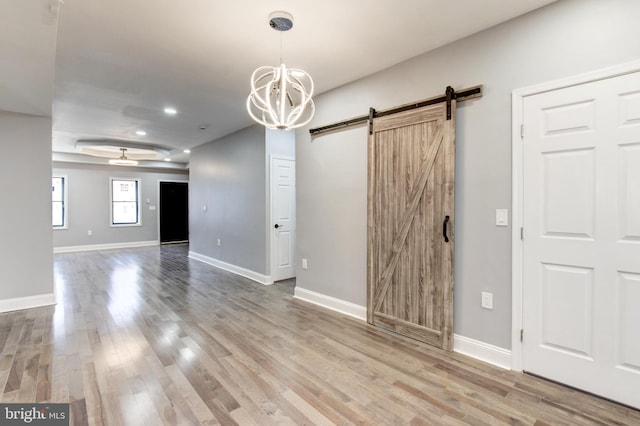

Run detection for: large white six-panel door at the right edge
[[522, 73, 640, 408]]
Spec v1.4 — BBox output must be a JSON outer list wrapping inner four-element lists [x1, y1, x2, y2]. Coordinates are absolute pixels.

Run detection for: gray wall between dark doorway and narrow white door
[[189, 126, 268, 275]]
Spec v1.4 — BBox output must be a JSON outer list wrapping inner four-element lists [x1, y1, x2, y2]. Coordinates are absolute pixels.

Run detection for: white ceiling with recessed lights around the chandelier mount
[[0, 0, 554, 166]]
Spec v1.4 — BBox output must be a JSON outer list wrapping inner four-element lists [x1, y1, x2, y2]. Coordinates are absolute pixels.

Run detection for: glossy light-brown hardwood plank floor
[[0, 245, 640, 425]]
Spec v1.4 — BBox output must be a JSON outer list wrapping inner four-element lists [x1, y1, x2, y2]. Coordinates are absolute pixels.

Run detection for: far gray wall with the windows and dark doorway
[[48, 162, 189, 248]]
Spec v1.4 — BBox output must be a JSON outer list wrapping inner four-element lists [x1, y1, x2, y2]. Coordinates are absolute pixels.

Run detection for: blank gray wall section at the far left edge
[[0, 111, 53, 300]]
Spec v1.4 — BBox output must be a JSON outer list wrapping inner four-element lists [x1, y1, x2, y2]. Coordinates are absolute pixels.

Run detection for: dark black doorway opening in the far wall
[[160, 182, 189, 244]]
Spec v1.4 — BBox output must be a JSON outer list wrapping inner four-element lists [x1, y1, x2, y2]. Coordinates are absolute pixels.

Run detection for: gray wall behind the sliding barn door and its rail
[[296, 0, 640, 348]]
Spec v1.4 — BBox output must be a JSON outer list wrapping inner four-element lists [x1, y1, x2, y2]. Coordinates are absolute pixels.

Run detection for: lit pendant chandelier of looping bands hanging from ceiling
[[247, 12, 315, 130]]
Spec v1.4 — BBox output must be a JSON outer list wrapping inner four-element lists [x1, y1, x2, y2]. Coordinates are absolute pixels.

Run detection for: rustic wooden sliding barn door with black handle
[[367, 101, 455, 350]]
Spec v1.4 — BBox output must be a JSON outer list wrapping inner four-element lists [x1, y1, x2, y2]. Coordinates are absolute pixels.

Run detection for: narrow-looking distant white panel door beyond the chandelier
[[271, 157, 296, 281]]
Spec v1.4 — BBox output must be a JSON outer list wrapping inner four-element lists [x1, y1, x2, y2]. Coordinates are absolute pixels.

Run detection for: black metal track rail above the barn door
[[309, 85, 482, 136]]
